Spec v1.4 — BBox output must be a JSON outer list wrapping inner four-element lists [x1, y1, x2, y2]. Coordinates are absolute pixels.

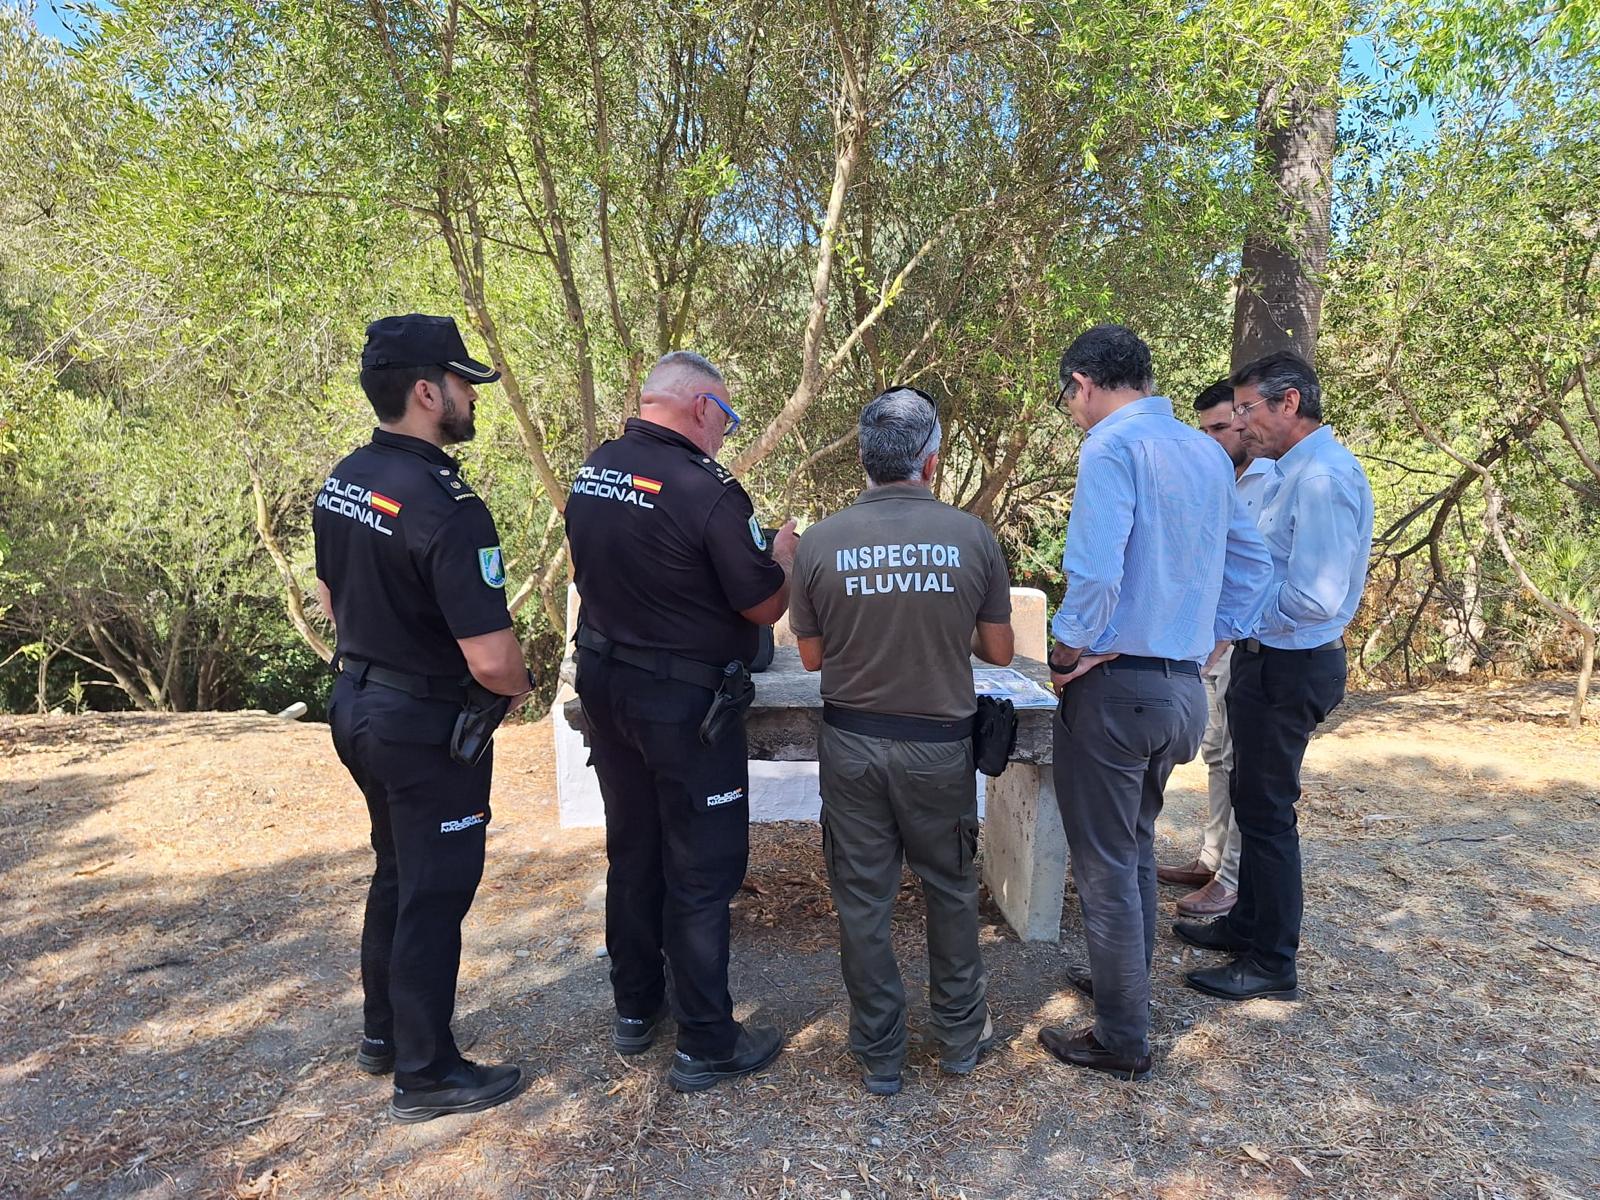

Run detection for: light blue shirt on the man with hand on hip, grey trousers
[[1050, 395, 1272, 662]]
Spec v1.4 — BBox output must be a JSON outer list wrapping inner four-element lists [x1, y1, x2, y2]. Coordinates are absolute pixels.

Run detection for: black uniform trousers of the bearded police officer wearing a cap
[[328, 675, 494, 1088]]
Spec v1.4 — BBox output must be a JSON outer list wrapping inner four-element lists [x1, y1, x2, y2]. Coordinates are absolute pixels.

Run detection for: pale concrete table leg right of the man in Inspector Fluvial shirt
[[984, 763, 1067, 942]]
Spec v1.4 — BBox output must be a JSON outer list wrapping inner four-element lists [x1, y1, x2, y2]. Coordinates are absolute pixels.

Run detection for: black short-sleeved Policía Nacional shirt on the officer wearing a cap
[[312, 429, 510, 741]]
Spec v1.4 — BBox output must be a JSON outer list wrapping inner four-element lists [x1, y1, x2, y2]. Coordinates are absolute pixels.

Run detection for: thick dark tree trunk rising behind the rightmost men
[[1232, 76, 1342, 368]]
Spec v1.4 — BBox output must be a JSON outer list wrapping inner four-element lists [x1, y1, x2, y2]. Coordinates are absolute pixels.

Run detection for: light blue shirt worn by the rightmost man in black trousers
[[1254, 426, 1373, 650]]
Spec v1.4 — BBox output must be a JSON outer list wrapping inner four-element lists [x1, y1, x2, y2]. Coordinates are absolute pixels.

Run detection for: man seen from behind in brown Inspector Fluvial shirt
[[789, 387, 1013, 1096]]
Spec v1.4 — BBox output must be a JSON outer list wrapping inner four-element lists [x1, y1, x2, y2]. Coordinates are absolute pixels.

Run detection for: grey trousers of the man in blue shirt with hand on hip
[[1053, 662, 1206, 1056]]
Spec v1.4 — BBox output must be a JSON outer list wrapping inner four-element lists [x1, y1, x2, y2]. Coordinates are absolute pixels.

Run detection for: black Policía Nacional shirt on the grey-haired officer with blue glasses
[[566, 418, 784, 667]]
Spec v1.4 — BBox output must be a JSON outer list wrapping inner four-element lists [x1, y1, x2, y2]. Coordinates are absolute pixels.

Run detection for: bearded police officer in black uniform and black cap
[[312, 314, 531, 1122]]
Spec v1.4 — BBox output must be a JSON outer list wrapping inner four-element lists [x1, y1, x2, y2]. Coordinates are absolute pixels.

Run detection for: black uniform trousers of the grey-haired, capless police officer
[[578, 650, 750, 1058]]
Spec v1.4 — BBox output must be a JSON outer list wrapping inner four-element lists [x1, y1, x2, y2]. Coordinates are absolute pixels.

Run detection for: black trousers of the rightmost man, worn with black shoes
[[1224, 645, 1346, 974]]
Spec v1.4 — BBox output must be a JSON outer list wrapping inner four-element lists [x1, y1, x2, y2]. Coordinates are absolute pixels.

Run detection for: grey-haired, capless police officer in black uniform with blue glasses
[[566, 350, 797, 1091]]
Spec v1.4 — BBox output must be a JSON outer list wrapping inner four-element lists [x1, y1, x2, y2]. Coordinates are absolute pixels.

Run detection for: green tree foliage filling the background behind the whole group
[[0, 0, 1600, 707]]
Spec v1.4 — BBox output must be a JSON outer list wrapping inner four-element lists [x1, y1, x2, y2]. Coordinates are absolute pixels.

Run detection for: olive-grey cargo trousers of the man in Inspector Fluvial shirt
[[818, 725, 989, 1074]]
